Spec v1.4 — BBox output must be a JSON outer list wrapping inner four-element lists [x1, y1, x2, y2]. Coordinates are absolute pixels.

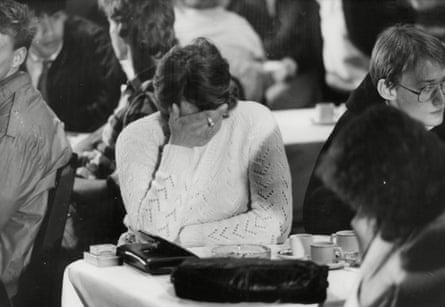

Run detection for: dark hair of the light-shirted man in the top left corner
[[0, 0, 36, 49]]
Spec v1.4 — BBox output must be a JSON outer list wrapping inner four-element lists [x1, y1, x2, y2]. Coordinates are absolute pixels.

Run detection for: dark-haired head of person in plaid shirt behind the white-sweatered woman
[[99, 0, 176, 57]]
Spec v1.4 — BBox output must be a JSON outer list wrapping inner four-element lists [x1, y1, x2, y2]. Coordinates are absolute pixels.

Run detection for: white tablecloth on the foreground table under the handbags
[[62, 246, 357, 307]]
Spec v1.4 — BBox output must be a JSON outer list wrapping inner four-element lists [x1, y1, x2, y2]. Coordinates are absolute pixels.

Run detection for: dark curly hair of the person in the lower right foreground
[[317, 106, 445, 242]]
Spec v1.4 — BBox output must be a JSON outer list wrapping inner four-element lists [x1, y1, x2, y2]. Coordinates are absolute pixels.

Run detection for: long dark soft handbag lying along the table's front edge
[[171, 258, 328, 304]]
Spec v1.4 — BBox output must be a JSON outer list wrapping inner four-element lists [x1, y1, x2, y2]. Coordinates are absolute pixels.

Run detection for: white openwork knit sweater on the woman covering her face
[[116, 101, 292, 246]]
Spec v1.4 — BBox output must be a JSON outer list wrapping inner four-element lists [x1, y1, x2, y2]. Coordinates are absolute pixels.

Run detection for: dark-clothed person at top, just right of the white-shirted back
[[228, 0, 324, 109]]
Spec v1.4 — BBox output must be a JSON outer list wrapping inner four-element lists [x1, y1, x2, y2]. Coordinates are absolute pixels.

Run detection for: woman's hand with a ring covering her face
[[168, 104, 228, 148]]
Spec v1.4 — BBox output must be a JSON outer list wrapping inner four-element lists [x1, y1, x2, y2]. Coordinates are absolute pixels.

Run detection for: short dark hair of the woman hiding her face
[[153, 38, 237, 117]]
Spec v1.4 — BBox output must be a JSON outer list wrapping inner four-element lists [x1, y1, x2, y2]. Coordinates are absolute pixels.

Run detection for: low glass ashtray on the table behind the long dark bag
[[212, 244, 271, 259]]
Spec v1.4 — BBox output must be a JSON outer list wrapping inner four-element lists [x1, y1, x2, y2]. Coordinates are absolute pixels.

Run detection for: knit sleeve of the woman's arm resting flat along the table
[[179, 107, 292, 246]]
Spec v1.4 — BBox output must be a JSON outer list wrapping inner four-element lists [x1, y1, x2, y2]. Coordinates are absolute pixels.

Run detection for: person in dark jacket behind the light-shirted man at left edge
[[21, 0, 125, 132]]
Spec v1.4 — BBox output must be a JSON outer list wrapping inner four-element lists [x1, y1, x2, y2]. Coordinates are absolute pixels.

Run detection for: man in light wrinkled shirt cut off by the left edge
[[0, 0, 71, 298]]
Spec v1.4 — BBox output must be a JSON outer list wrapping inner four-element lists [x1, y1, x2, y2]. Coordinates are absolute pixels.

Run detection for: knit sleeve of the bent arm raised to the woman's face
[[116, 118, 193, 241]]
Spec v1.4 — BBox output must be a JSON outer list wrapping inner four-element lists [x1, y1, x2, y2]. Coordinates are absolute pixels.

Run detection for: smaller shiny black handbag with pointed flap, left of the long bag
[[116, 232, 198, 275]]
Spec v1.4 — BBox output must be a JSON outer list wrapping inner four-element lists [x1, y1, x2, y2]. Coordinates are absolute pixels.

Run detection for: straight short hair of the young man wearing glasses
[[370, 25, 445, 88]]
